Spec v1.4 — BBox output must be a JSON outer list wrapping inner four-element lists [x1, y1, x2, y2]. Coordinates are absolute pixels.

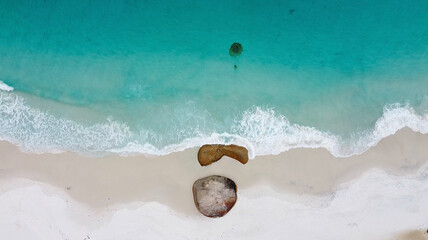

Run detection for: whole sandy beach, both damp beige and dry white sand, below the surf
[[0, 129, 428, 240]]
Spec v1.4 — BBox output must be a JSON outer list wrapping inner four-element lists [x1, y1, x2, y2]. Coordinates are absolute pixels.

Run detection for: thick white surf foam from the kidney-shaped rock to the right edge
[[235, 104, 428, 157]]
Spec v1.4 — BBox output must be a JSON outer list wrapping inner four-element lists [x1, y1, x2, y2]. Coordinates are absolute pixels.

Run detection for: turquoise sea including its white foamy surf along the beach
[[0, 0, 428, 157]]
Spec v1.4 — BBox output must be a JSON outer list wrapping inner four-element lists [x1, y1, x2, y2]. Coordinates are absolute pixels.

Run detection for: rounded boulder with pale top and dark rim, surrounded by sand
[[193, 175, 238, 218]]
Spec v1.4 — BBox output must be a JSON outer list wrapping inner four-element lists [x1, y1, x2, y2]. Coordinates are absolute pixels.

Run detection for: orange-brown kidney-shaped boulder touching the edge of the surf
[[198, 144, 248, 166]]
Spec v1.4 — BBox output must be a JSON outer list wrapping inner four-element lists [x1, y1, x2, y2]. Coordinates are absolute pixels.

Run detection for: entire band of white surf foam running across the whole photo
[[0, 92, 428, 158]]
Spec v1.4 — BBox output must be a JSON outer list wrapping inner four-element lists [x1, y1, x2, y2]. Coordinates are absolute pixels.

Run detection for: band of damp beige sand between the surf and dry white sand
[[0, 126, 428, 239]]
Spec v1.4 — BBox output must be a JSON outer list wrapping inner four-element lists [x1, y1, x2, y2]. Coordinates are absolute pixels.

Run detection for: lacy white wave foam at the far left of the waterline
[[0, 92, 132, 153]]
